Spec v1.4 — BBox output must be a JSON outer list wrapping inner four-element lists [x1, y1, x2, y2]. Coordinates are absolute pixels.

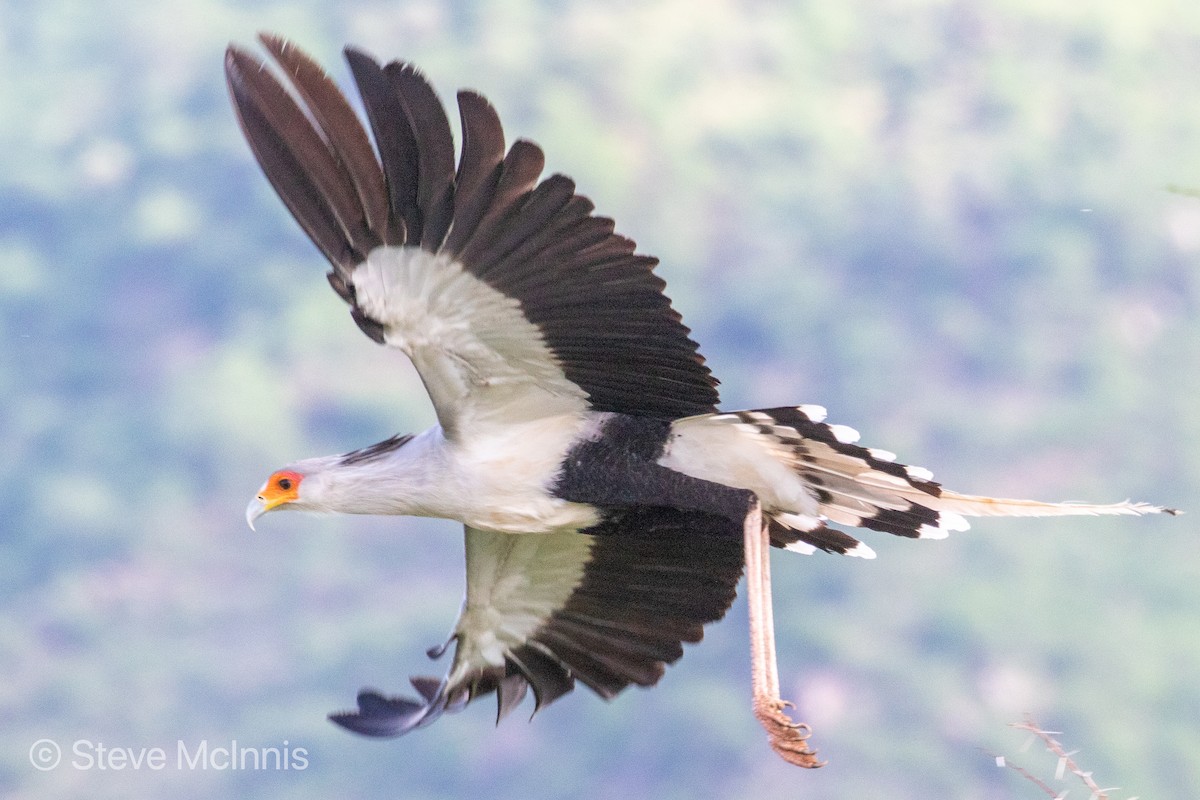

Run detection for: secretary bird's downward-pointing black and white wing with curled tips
[[331, 509, 743, 736]]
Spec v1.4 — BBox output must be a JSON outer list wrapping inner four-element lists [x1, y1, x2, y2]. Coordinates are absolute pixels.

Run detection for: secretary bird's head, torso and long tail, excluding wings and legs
[[246, 391, 1159, 558]]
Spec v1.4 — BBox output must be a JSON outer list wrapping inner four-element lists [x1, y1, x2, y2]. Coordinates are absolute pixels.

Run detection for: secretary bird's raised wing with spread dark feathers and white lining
[[226, 36, 718, 435]]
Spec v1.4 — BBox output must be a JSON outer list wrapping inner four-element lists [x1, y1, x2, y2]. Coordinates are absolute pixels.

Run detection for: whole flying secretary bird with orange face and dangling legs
[[226, 35, 1174, 766]]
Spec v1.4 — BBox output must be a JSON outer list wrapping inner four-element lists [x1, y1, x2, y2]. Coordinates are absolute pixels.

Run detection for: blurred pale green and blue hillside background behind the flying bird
[[0, 0, 1200, 800]]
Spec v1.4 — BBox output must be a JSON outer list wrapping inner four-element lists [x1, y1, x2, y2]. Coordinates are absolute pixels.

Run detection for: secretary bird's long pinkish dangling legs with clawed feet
[[744, 499, 824, 769]]
